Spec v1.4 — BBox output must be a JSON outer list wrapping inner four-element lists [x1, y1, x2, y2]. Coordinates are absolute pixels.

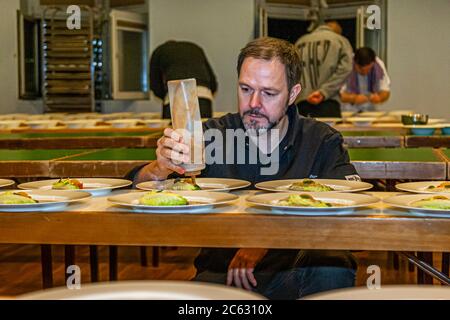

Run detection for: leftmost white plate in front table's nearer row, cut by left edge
[[0, 190, 91, 212]]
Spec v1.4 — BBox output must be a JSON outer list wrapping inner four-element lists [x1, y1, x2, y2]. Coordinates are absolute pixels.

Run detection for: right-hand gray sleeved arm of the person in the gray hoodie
[[318, 39, 353, 100]]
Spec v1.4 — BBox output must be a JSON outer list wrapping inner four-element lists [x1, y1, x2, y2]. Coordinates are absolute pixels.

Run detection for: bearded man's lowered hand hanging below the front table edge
[[227, 249, 267, 290]]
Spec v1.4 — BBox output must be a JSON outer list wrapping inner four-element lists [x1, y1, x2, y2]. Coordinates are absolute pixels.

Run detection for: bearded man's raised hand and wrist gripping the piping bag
[[134, 128, 190, 181]]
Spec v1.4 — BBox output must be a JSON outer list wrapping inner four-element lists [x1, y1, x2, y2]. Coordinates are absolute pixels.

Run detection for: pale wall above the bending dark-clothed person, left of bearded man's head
[[149, 0, 254, 111]]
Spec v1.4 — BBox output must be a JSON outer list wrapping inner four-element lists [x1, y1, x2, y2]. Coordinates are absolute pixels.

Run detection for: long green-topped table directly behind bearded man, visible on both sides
[[0, 148, 448, 180]]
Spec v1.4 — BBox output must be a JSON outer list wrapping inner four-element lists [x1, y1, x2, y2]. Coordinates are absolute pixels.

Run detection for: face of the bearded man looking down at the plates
[[238, 57, 300, 133]]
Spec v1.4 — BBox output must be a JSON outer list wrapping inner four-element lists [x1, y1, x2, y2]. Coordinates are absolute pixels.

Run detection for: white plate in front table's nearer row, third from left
[[246, 192, 380, 216]]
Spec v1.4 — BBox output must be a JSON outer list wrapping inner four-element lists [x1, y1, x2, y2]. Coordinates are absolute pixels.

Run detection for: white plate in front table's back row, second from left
[[18, 178, 132, 197]]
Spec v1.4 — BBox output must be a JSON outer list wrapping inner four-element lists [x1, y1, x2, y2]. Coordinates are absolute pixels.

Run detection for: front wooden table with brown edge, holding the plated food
[[0, 191, 450, 252]]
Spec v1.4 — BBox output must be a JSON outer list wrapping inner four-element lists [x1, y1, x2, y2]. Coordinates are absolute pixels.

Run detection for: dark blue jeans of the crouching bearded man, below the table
[[194, 250, 356, 300]]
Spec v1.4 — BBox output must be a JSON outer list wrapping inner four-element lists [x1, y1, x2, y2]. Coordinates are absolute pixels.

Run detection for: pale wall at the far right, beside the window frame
[[385, 0, 450, 120]]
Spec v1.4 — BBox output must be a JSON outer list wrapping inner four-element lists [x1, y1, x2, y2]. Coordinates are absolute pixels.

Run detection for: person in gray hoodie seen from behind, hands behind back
[[295, 22, 353, 117]]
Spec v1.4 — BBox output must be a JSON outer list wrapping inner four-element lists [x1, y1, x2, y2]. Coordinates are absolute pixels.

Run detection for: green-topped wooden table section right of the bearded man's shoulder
[[349, 148, 447, 180]]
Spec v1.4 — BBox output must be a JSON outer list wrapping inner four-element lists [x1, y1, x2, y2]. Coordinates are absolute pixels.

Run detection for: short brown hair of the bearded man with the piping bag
[[237, 37, 301, 91]]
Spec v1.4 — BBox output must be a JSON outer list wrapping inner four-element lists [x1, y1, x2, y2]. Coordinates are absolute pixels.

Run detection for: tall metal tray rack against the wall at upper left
[[41, 6, 95, 112]]
